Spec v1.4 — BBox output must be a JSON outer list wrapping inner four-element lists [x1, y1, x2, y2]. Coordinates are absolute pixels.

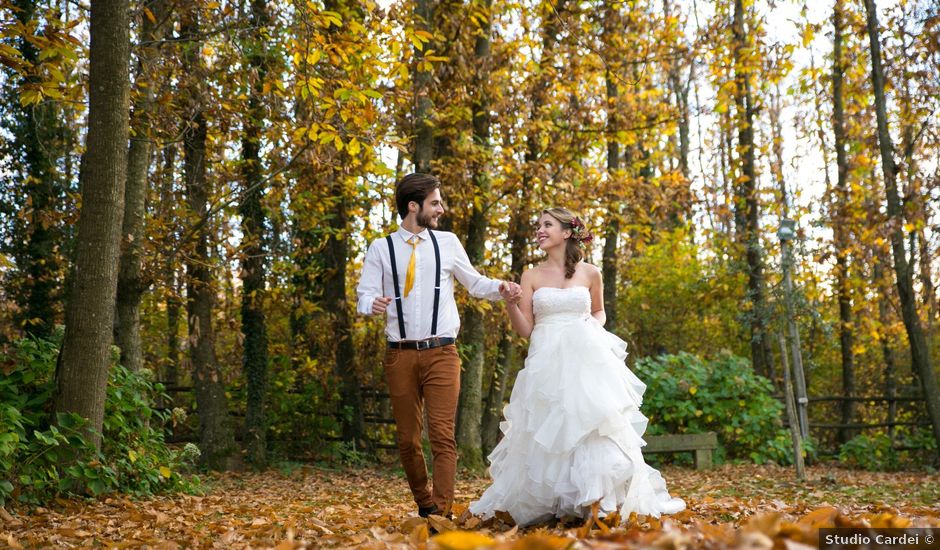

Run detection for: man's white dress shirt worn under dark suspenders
[[356, 228, 502, 342]]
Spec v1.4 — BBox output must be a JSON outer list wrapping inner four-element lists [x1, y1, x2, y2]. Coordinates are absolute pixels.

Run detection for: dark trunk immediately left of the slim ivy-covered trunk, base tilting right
[[180, 8, 235, 470]]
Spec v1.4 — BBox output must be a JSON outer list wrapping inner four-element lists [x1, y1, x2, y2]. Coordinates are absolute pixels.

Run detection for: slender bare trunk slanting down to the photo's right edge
[[865, 0, 940, 461]]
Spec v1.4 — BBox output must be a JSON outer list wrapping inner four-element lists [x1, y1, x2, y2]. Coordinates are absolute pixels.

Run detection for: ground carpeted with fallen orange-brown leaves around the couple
[[0, 465, 940, 549]]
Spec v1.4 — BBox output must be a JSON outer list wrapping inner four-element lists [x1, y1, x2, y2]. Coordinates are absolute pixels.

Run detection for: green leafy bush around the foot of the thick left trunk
[[0, 335, 199, 504]]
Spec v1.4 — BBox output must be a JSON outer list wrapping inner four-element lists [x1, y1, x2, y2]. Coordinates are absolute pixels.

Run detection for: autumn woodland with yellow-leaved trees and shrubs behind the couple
[[0, 0, 940, 506]]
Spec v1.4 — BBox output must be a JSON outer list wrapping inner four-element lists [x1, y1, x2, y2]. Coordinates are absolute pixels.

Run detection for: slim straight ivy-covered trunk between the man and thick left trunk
[[239, 0, 270, 468]]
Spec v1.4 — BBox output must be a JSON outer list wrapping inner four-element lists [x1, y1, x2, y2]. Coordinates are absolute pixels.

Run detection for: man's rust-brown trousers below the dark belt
[[385, 344, 460, 511]]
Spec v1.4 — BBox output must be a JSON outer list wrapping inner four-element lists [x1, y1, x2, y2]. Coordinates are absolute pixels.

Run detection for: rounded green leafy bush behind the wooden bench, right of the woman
[[635, 352, 789, 463]]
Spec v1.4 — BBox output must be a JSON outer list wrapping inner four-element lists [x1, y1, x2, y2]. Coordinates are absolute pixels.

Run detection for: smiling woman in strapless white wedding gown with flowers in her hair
[[470, 208, 685, 525]]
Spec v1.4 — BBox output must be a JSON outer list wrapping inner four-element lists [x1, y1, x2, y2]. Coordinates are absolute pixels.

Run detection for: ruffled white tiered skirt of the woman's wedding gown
[[470, 316, 685, 525]]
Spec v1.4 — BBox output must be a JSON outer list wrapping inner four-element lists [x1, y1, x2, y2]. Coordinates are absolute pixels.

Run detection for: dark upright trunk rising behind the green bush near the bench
[[732, 0, 770, 376]]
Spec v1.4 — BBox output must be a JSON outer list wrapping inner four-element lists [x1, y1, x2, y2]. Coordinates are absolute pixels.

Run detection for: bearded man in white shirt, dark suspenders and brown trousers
[[356, 173, 521, 517]]
